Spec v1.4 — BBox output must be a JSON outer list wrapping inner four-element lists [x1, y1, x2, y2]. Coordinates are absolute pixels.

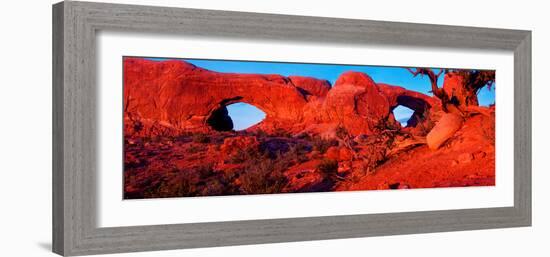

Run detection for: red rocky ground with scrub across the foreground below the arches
[[124, 110, 495, 199]]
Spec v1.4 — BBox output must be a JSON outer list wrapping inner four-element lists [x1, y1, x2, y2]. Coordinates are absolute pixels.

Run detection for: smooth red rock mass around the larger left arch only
[[124, 58, 307, 134]]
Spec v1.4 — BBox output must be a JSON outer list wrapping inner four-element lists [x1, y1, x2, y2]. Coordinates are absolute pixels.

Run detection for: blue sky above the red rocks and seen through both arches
[[144, 58, 495, 130]]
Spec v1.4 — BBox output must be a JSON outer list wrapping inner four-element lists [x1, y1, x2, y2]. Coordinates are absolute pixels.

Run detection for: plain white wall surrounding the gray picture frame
[[0, 0, 550, 257]]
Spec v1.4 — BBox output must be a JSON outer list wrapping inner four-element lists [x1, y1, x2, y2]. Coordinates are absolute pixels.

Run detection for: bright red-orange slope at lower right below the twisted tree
[[337, 112, 495, 191]]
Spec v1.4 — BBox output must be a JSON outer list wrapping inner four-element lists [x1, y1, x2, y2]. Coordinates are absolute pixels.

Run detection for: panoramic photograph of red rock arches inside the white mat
[[122, 56, 496, 199]]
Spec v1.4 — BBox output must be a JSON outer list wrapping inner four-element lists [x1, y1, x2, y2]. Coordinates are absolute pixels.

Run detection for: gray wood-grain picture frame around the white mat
[[53, 1, 531, 256]]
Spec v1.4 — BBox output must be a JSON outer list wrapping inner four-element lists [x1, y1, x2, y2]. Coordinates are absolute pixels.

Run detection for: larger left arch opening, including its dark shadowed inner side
[[206, 99, 266, 131]]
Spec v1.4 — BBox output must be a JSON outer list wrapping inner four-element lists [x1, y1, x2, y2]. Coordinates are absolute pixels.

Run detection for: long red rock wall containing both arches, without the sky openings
[[124, 58, 441, 138]]
